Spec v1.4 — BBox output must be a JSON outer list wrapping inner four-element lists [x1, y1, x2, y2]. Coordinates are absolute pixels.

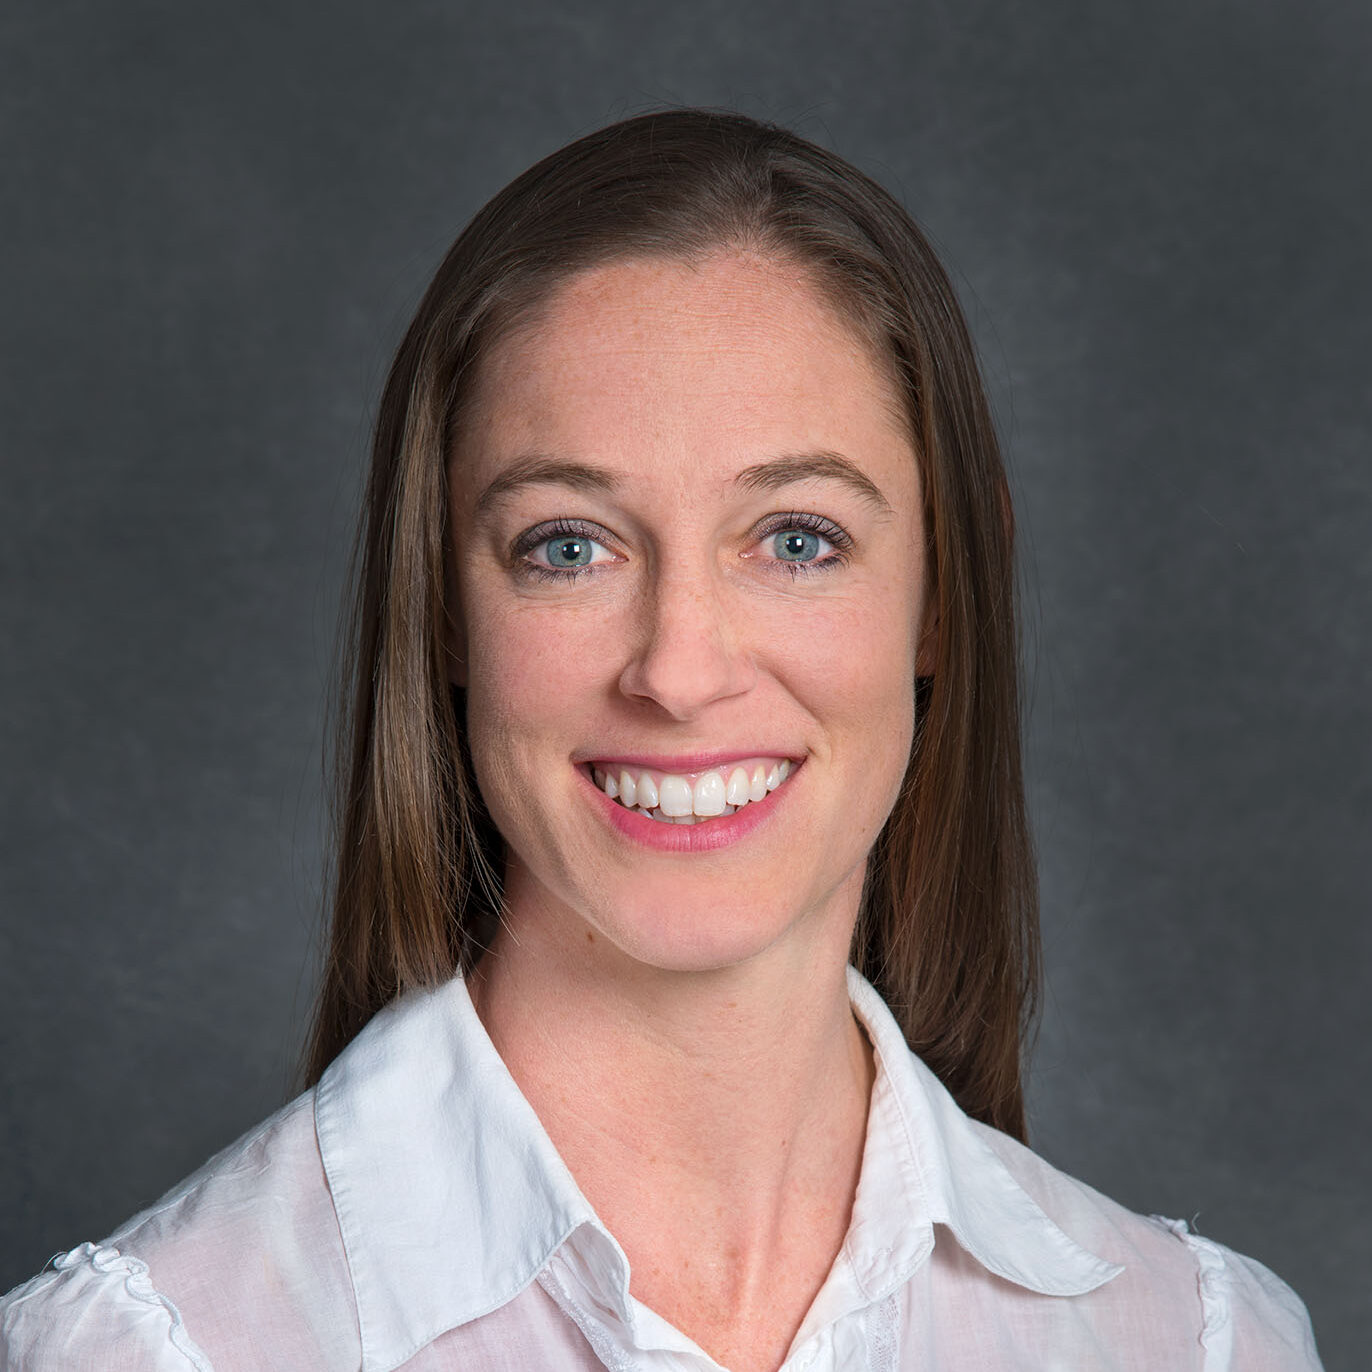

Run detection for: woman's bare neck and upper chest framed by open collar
[[472, 889, 873, 1367]]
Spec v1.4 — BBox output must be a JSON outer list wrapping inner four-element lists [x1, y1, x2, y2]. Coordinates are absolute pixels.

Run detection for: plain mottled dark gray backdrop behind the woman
[[0, 0, 1372, 1368]]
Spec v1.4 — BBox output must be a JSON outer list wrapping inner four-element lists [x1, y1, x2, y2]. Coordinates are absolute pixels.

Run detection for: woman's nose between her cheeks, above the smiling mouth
[[619, 572, 757, 722]]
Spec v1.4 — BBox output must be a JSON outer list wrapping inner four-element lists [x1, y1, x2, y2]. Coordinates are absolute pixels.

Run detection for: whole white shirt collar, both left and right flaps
[[314, 969, 1122, 1372]]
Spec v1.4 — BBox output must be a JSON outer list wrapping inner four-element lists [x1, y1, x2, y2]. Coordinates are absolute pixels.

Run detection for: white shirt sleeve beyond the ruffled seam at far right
[[1158, 1216, 1323, 1372]]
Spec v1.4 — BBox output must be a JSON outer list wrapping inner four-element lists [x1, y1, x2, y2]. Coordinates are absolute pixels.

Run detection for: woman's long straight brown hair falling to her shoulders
[[306, 110, 1039, 1137]]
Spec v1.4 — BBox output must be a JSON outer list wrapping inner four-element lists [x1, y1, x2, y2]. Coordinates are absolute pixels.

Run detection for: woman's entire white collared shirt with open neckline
[[0, 969, 1320, 1372]]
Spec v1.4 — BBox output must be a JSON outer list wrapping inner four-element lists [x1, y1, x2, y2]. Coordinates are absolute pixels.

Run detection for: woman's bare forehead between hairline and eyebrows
[[454, 251, 918, 499]]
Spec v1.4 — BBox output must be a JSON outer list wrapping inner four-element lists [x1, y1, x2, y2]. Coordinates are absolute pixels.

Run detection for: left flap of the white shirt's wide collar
[[314, 978, 628, 1372]]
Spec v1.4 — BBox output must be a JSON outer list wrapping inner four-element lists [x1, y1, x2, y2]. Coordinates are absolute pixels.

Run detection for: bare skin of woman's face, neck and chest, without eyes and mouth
[[450, 250, 932, 1372]]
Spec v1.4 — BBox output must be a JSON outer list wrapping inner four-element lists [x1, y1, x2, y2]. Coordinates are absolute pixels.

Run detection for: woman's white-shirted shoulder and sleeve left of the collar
[[0, 1092, 358, 1372]]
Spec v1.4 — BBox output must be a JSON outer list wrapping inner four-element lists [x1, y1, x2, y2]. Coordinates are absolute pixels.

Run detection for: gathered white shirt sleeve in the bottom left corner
[[0, 1243, 214, 1372]]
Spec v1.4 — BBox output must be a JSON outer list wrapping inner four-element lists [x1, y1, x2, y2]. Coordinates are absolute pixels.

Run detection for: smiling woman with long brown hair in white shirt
[[0, 111, 1318, 1372]]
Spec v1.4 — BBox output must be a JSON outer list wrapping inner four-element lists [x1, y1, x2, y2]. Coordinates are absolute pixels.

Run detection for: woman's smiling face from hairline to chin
[[451, 251, 926, 970]]
